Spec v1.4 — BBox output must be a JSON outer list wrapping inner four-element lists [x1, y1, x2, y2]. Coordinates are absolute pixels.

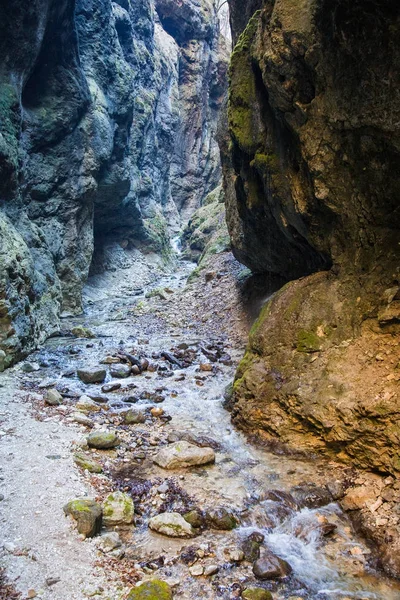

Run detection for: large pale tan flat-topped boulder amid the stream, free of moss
[[154, 441, 215, 469]]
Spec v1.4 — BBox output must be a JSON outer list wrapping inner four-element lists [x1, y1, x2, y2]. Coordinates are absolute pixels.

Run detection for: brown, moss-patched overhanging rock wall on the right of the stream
[[222, 0, 400, 475]]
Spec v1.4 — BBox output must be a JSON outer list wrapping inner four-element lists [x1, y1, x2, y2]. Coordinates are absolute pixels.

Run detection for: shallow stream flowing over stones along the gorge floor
[[5, 250, 400, 600]]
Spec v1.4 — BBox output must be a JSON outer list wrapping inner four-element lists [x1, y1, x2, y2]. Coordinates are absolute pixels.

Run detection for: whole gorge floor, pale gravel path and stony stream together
[[0, 253, 400, 600]]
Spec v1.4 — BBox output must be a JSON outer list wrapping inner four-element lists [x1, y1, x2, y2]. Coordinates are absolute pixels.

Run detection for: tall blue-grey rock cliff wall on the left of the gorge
[[0, 0, 227, 365]]
